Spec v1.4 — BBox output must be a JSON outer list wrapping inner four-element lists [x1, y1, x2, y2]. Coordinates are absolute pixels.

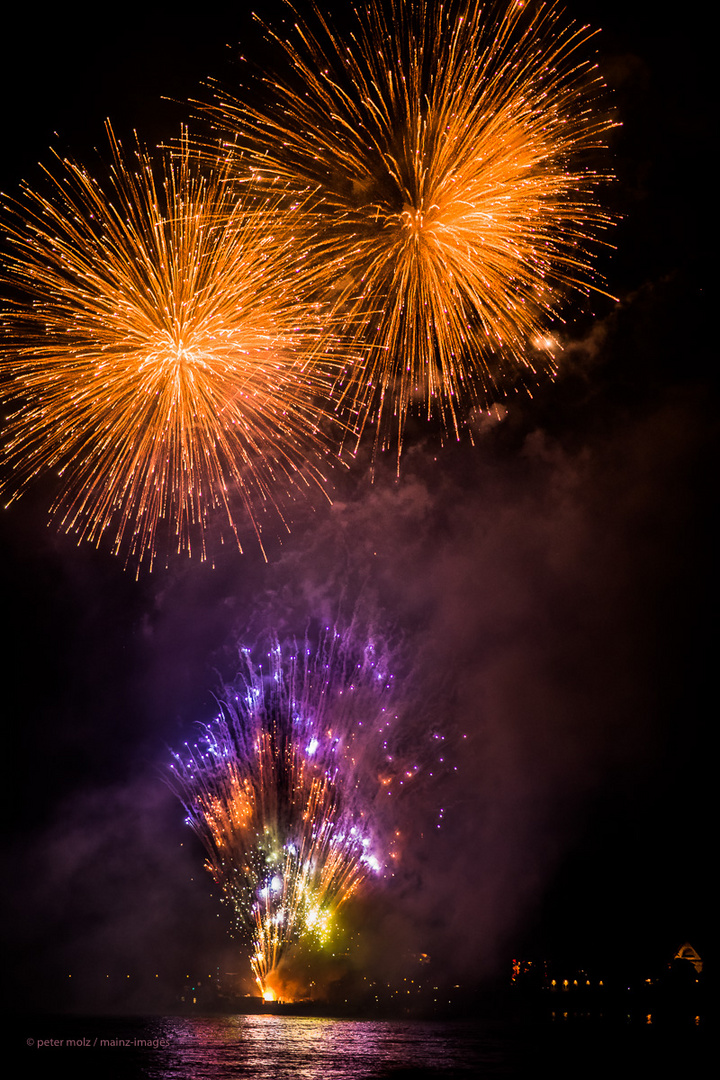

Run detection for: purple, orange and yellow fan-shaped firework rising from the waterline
[[169, 631, 433, 995]]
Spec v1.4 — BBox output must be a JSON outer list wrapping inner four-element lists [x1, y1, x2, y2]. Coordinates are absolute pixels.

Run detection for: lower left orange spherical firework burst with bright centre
[[0, 131, 343, 568]]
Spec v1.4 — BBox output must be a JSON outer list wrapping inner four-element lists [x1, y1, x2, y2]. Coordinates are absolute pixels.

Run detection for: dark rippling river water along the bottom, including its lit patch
[[21, 1015, 704, 1080]]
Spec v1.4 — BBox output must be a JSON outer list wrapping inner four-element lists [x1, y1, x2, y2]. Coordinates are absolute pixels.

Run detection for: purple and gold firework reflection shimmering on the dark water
[[146, 1015, 503, 1080]]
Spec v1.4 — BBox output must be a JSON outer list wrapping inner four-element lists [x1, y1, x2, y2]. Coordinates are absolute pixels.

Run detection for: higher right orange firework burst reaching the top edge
[[205, 0, 612, 455]]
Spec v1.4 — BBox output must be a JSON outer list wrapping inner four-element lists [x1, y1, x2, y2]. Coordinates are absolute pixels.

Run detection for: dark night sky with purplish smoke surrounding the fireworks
[[0, 0, 716, 1009]]
